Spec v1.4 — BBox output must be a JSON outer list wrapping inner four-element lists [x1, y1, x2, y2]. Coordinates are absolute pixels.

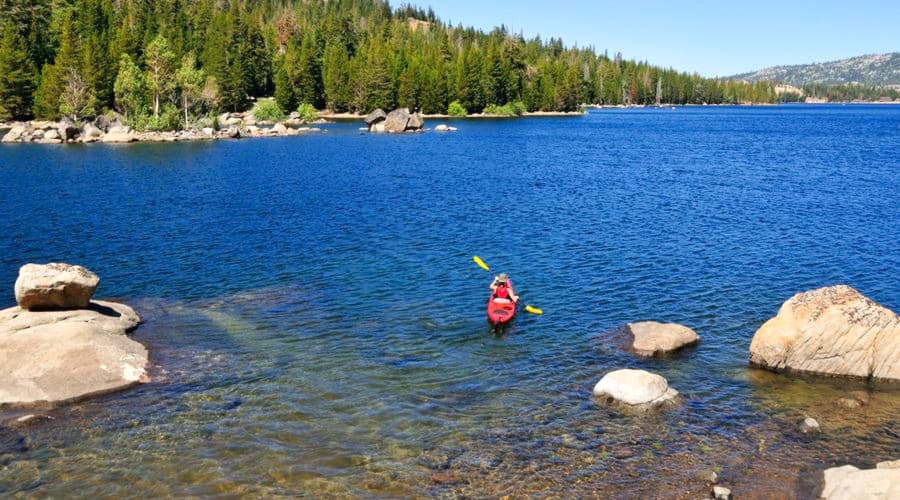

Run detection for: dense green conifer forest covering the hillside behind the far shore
[[0, 0, 777, 130]]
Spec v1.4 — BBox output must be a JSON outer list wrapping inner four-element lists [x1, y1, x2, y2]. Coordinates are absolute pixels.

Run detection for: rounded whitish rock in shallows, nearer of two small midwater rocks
[[594, 369, 678, 410]]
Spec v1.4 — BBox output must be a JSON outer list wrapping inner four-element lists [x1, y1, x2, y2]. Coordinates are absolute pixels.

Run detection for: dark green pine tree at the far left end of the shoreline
[[0, 24, 35, 120]]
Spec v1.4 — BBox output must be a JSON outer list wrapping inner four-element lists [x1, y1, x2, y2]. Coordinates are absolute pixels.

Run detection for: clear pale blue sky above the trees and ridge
[[402, 0, 900, 76]]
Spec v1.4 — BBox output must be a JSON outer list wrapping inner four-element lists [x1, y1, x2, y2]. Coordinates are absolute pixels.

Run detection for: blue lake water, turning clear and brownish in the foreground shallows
[[0, 106, 900, 497]]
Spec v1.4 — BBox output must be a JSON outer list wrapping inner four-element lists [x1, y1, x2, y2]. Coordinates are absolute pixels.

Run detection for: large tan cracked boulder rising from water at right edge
[[750, 285, 900, 380]]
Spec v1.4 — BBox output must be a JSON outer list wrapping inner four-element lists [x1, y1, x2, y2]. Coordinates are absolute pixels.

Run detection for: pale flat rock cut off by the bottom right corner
[[819, 465, 900, 500]]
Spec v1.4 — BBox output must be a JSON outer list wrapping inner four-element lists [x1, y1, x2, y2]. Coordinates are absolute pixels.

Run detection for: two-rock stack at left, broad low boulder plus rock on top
[[0, 263, 148, 405]]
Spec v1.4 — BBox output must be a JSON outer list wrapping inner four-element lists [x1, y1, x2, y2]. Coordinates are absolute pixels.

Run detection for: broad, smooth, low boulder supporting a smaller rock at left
[[0, 301, 148, 405]]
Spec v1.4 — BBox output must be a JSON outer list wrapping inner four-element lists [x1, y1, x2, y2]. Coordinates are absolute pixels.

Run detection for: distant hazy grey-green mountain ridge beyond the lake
[[730, 52, 900, 87]]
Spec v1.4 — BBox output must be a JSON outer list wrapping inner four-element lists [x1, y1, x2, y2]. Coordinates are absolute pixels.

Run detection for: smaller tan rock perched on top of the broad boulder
[[15, 262, 100, 309]]
